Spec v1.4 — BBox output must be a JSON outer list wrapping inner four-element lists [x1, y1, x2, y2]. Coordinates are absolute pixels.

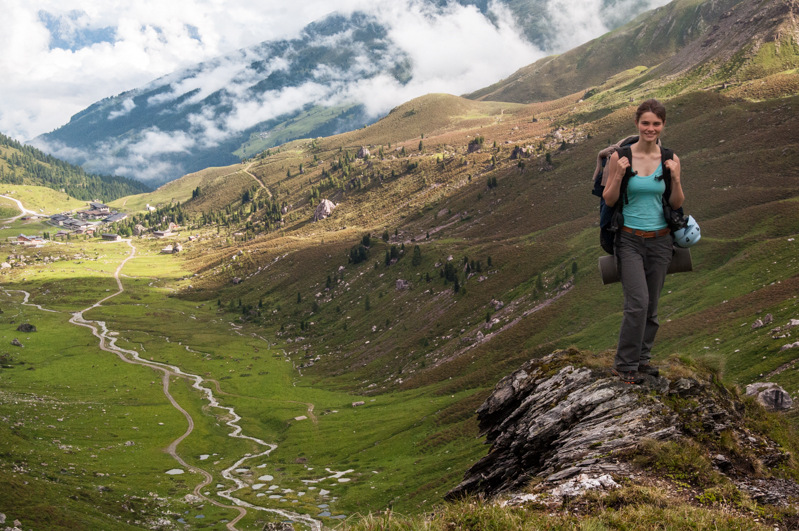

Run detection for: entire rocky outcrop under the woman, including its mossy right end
[[447, 350, 789, 499]]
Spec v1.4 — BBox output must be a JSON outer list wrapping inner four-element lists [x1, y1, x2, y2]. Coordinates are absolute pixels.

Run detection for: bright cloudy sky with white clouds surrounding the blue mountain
[[0, 0, 666, 179]]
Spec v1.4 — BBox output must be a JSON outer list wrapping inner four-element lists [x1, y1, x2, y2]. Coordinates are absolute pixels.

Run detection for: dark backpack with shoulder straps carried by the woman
[[591, 136, 684, 254]]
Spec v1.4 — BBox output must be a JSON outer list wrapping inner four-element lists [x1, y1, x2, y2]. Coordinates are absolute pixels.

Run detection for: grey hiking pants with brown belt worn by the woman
[[614, 232, 673, 371]]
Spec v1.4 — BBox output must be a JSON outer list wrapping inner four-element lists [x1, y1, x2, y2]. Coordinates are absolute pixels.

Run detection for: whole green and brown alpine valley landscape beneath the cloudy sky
[[0, 0, 799, 531]]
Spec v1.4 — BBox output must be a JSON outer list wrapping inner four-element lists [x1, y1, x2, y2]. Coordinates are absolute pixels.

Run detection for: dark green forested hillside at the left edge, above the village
[[0, 134, 150, 201]]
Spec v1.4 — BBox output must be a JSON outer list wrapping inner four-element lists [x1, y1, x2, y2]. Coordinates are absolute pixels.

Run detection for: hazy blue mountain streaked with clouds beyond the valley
[[33, 0, 668, 184]]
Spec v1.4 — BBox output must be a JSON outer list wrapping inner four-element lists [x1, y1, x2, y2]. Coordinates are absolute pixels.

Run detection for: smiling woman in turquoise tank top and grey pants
[[603, 99, 685, 384]]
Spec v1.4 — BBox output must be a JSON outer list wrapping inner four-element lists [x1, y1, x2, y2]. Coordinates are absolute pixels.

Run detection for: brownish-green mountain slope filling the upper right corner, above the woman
[[466, 0, 799, 103]]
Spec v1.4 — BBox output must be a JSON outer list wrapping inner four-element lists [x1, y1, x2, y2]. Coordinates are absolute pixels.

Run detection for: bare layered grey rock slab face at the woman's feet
[[447, 352, 680, 498]]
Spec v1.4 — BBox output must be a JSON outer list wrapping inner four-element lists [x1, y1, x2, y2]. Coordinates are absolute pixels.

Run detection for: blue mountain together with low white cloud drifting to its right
[[18, 0, 664, 184]]
